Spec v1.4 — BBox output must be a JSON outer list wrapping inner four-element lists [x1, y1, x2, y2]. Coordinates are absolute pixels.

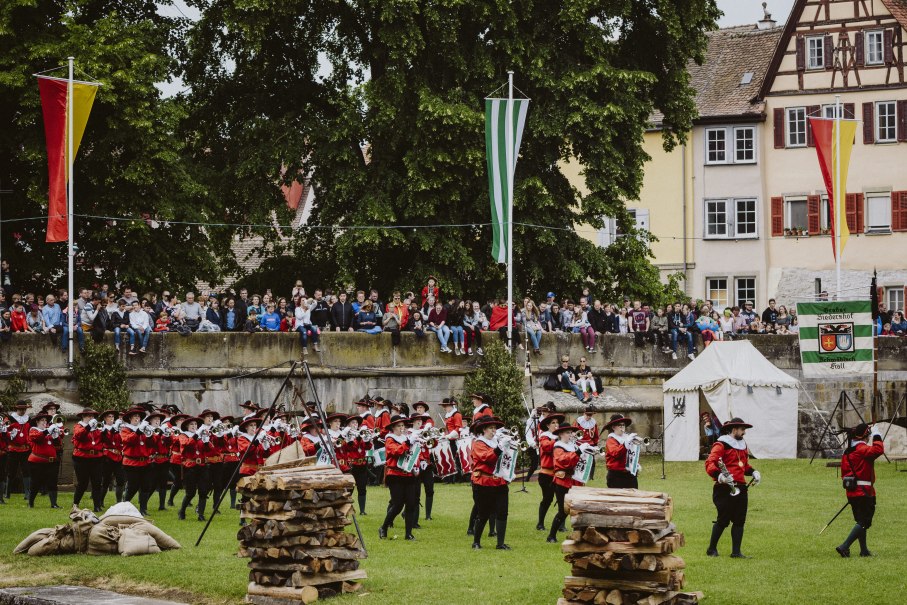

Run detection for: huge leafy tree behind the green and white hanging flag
[[185, 0, 719, 300]]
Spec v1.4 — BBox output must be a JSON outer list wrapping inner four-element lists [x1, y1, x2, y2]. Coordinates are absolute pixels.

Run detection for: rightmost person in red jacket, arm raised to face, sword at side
[[835, 423, 885, 557]]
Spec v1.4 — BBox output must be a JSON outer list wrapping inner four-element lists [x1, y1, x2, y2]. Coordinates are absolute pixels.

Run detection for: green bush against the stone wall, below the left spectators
[[75, 340, 129, 412]]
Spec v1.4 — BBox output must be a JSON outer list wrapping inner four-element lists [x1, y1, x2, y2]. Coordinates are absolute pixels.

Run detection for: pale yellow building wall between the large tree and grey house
[[561, 130, 693, 276]]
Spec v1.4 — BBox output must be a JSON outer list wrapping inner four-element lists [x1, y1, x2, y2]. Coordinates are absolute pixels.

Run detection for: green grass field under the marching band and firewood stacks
[[0, 458, 907, 605]]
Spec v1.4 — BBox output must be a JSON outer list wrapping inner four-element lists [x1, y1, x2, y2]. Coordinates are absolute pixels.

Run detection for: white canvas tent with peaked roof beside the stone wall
[[663, 340, 800, 460]]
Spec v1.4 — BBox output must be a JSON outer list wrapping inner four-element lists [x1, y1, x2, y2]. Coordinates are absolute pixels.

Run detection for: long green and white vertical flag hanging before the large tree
[[485, 99, 529, 263]]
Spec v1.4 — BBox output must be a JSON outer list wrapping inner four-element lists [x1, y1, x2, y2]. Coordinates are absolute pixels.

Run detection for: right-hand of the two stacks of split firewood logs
[[558, 487, 702, 605]]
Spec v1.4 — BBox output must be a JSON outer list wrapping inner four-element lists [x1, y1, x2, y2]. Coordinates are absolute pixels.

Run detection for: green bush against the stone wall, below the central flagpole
[[461, 338, 526, 428]]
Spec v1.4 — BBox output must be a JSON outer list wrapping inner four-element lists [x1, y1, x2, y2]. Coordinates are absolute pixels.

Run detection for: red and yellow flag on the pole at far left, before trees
[[38, 76, 98, 242]]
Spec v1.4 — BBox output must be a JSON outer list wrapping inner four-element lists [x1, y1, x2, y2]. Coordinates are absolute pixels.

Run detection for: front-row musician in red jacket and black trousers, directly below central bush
[[469, 415, 511, 550]]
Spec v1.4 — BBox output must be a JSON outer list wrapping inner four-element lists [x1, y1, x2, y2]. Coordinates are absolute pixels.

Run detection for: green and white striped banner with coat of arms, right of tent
[[797, 300, 874, 376]]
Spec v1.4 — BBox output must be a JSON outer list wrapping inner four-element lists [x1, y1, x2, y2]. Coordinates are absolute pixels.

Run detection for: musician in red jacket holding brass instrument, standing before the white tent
[[705, 418, 764, 559]]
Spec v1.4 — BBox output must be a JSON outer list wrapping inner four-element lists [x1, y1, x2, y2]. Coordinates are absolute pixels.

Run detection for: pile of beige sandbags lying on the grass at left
[[13, 502, 180, 557]]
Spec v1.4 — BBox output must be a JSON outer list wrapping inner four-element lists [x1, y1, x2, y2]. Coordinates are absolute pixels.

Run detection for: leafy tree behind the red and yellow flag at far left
[[0, 0, 235, 292]]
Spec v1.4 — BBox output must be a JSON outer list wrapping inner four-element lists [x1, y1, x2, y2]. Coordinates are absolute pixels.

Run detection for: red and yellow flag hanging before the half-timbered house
[[809, 118, 857, 259]]
